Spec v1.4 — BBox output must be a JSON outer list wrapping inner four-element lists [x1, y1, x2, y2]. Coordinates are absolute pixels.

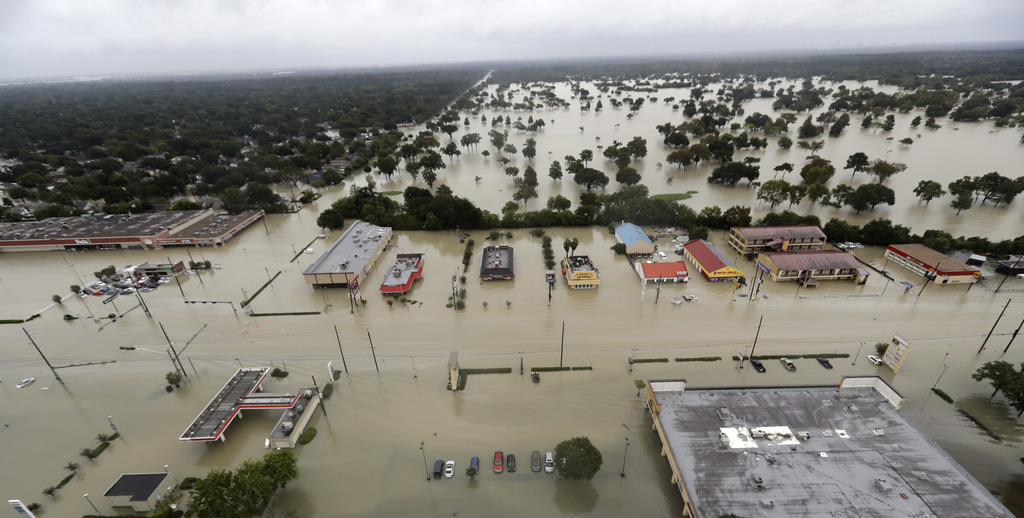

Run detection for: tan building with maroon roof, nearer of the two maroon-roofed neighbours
[[757, 250, 869, 286]]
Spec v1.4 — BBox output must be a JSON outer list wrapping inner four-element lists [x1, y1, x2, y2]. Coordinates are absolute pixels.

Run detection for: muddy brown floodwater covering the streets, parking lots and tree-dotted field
[[6, 78, 1024, 516]]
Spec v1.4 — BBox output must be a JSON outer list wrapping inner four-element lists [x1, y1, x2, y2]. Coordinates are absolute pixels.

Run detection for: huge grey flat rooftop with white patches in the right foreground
[[649, 377, 1013, 518]]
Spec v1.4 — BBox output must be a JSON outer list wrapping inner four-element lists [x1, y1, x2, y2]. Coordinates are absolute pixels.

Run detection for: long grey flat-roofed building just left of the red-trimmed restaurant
[[302, 220, 392, 288]]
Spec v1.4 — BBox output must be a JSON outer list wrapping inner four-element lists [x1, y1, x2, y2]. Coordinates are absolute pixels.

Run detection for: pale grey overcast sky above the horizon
[[0, 0, 1024, 79]]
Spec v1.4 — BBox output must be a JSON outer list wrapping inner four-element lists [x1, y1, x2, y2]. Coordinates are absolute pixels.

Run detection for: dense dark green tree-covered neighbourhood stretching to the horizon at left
[[0, 69, 481, 219]]
